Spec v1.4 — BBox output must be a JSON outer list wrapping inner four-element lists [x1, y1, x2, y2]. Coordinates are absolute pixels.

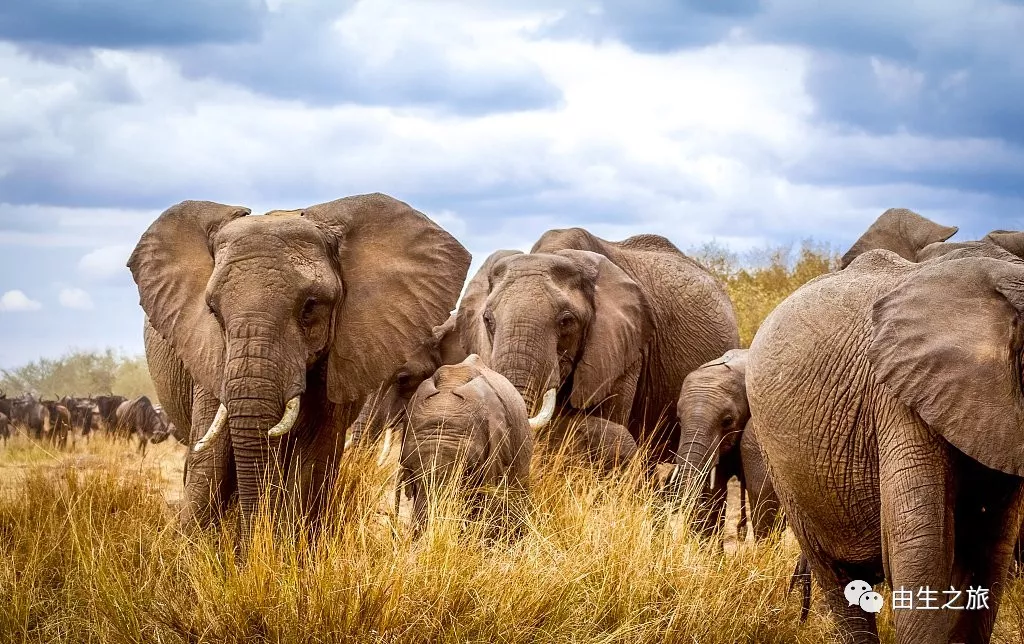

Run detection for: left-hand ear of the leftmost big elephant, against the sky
[[128, 201, 250, 396]]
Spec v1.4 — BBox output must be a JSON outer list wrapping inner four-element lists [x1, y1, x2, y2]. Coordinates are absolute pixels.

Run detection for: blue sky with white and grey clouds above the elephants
[[0, 0, 1024, 368]]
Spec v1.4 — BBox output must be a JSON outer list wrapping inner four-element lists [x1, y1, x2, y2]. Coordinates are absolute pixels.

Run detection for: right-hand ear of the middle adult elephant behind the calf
[[557, 251, 653, 410]]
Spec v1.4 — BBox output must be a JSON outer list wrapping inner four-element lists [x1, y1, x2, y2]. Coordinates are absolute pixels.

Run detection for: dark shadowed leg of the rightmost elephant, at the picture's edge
[[943, 453, 1024, 642]]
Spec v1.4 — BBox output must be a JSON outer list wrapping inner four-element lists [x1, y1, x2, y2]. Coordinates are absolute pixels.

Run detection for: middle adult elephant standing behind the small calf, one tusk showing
[[457, 228, 739, 461]]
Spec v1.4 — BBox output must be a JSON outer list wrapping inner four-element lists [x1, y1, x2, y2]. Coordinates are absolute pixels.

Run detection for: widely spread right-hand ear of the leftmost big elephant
[[302, 192, 470, 404]]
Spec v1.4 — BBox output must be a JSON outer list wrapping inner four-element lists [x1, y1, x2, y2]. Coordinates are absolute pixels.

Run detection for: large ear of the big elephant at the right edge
[[867, 257, 1024, 476]]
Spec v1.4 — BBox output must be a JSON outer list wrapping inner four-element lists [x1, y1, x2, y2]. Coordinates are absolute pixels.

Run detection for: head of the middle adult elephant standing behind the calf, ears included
[[458, 245, 652, 412]]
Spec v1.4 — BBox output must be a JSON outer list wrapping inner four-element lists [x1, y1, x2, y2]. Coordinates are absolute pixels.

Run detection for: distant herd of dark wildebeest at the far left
[[0, 392, 185, 455]]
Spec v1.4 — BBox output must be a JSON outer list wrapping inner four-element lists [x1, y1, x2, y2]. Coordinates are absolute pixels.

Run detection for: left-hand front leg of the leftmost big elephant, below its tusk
[[179, 387, 237, 528]]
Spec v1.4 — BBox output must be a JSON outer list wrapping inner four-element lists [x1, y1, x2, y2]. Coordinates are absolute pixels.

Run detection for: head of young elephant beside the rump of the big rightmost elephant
[[676, 349, 751, 489]]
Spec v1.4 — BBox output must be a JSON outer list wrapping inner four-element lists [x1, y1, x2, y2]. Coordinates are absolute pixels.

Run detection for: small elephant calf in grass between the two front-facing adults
[[399, 354, 534, 529]]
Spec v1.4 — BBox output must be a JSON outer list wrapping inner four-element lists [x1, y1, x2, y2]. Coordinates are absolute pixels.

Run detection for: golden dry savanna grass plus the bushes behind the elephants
[[6, 242, 1024, 644]]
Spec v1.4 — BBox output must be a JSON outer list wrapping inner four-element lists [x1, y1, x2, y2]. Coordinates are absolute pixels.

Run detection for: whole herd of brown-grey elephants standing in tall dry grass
[[128, 194, 1024, 642]]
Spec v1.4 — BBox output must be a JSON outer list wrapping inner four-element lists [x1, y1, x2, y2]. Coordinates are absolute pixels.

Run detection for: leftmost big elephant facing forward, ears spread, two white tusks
[[128, 194, 470, 550]]
